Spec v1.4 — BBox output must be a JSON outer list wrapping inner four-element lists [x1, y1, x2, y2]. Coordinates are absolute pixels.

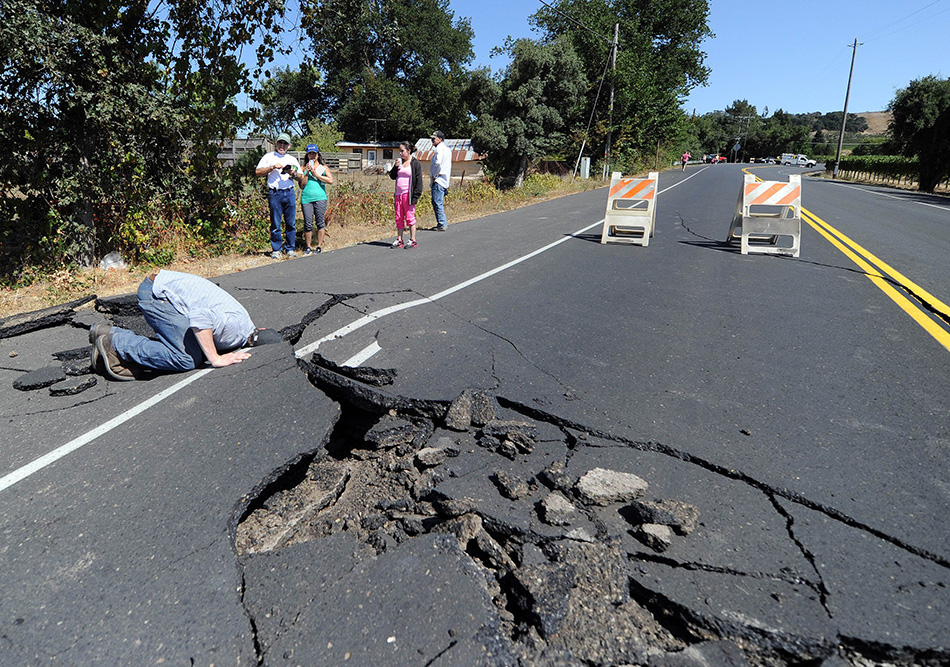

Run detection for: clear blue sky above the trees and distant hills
[[449, 0, 950, 114]]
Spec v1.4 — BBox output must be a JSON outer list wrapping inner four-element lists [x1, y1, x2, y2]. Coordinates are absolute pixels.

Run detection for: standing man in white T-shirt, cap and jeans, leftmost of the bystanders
[[255, 132, 302, 259]]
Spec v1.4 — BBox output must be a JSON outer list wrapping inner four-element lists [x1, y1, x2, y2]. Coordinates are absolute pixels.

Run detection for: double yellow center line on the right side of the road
[[802, 208, 950, 351]]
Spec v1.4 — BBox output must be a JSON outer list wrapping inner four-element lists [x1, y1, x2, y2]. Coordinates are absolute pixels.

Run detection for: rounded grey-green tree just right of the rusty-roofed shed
[[472, 38, 588, 187]]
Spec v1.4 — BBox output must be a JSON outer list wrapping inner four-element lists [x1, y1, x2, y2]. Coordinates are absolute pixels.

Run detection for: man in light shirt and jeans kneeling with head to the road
[[89, 269, 281, 381]]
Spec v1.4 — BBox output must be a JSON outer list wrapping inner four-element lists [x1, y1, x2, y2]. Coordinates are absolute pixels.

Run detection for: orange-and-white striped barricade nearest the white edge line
[[600, 171, 660, 246]]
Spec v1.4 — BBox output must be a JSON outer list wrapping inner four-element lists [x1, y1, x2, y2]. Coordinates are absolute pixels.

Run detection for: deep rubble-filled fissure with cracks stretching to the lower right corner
[[236, 355, 950, 665]]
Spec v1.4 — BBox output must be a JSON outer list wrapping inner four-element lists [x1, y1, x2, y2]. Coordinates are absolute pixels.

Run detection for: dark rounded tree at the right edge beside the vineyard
[[888, 76, 950, 192]]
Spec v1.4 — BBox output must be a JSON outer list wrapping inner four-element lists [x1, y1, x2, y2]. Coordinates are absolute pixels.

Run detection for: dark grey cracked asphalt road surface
[[0, 165, 950, 664]]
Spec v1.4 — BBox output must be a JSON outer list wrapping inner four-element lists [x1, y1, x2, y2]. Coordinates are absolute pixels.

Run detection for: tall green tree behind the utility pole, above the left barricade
[[532, 0, 713, 164]]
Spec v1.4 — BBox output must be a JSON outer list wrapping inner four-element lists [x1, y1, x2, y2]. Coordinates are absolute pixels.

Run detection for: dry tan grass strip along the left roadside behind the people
[[0, 175, 603, 318]]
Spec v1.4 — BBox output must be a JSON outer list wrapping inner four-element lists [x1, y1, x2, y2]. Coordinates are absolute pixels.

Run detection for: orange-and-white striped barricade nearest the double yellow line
[[726, 174, 802, 257]]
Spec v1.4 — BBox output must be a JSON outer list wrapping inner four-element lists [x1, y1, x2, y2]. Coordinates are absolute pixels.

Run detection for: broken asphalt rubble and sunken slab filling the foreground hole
[[236, 390, 840, 665]]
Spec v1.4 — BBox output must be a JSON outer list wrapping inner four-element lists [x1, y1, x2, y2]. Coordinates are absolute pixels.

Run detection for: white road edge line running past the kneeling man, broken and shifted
[[0, 175, 692, 492]]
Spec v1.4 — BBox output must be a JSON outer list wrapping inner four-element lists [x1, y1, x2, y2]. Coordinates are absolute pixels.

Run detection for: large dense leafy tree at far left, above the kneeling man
[[0, 0, 283, 264]]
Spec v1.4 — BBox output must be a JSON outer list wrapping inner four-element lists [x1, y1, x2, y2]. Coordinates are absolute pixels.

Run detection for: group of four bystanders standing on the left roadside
[[255, 130, 452, 259]]
